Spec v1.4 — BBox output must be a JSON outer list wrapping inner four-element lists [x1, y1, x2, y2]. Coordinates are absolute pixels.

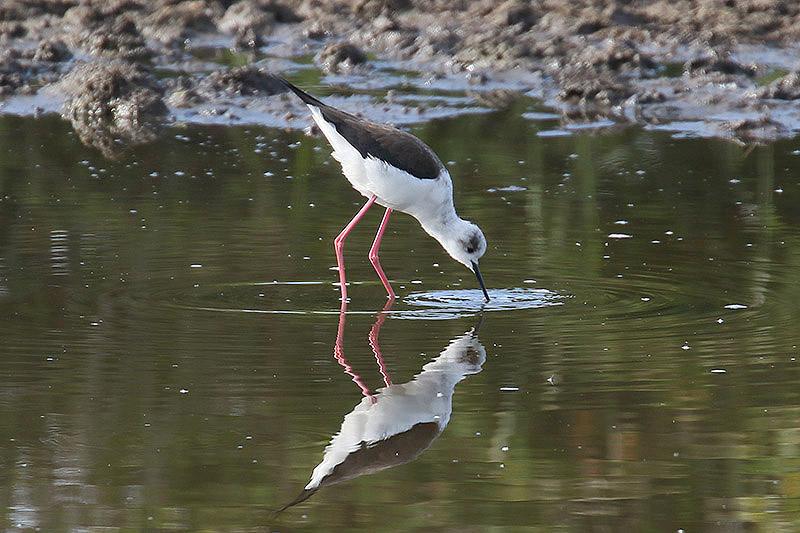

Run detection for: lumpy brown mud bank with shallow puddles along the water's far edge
[[0, 0, 800, 154]]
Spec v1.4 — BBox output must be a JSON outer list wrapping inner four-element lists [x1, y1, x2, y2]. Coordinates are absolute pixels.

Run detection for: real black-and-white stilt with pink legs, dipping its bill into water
[[278, 77, 489, 307]]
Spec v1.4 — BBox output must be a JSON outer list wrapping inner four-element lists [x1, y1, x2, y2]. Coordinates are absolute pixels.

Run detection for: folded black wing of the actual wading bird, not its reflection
[[278, 78, 444, 179]]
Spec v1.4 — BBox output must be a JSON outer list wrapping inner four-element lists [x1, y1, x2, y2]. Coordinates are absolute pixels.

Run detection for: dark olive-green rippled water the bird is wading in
[[0, 109, 800, 531]]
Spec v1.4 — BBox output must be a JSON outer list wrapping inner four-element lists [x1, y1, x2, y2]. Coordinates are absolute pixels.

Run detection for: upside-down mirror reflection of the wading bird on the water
[[279, 302, 486, 512]]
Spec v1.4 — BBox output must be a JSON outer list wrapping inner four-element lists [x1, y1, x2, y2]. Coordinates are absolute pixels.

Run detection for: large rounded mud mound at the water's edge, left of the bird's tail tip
[[49, 59, 168, 158]]
